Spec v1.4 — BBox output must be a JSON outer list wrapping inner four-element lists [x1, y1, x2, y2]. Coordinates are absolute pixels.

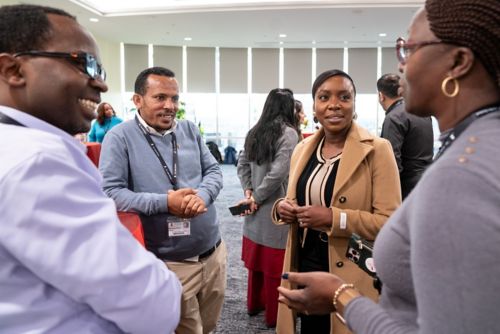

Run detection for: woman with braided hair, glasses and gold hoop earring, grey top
[[280, 0, 500, 333]]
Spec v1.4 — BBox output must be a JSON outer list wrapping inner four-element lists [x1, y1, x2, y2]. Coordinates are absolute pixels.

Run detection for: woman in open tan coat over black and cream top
[[273, 70, 401, 334]]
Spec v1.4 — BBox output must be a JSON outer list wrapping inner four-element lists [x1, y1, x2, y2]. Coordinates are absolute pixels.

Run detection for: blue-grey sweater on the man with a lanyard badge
[[99, 120, 222, 261]]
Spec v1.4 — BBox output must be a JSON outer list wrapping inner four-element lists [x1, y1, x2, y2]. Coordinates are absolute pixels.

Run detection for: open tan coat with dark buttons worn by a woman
[[272, 122, 401, 334]]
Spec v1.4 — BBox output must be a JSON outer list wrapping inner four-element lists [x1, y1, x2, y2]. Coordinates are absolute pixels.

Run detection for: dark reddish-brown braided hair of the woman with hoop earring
[[425, 0, 500, 87]]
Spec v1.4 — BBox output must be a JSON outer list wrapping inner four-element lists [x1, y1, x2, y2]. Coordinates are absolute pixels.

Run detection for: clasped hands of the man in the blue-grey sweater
[[167, 188, 207, 218]]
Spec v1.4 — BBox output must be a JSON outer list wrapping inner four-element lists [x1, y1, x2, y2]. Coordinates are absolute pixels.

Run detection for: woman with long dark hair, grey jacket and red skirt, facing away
[[237, 88, 299, 327]]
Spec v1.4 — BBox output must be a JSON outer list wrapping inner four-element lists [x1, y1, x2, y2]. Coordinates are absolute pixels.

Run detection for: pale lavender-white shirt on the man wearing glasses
[[0, 106, 181, 334]]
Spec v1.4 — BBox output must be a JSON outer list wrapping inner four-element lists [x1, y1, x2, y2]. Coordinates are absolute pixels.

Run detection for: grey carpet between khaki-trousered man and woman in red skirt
[[214, 165, 274, 334]]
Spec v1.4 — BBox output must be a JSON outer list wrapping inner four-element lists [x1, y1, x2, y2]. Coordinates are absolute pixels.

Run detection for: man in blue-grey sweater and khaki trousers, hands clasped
[[99, 67, 226, 334]]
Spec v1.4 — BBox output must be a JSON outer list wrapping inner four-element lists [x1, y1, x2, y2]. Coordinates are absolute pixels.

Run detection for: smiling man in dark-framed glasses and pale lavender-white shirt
[[0, 5, 181, 334]]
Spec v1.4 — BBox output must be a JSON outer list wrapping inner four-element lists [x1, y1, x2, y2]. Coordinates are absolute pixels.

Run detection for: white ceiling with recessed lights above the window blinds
[[0, 0, 423, 48]]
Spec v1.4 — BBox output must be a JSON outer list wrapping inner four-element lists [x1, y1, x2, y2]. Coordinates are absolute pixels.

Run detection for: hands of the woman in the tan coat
[[277, 199, 332, 231]]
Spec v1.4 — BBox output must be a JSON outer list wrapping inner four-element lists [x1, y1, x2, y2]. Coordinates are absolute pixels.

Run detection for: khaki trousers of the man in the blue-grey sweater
[[166, 241, 227, 334]]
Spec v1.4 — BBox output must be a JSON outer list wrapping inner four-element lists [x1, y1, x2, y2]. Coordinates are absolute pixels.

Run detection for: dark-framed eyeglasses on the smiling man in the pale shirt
[[14, 51, 106, 81]]
